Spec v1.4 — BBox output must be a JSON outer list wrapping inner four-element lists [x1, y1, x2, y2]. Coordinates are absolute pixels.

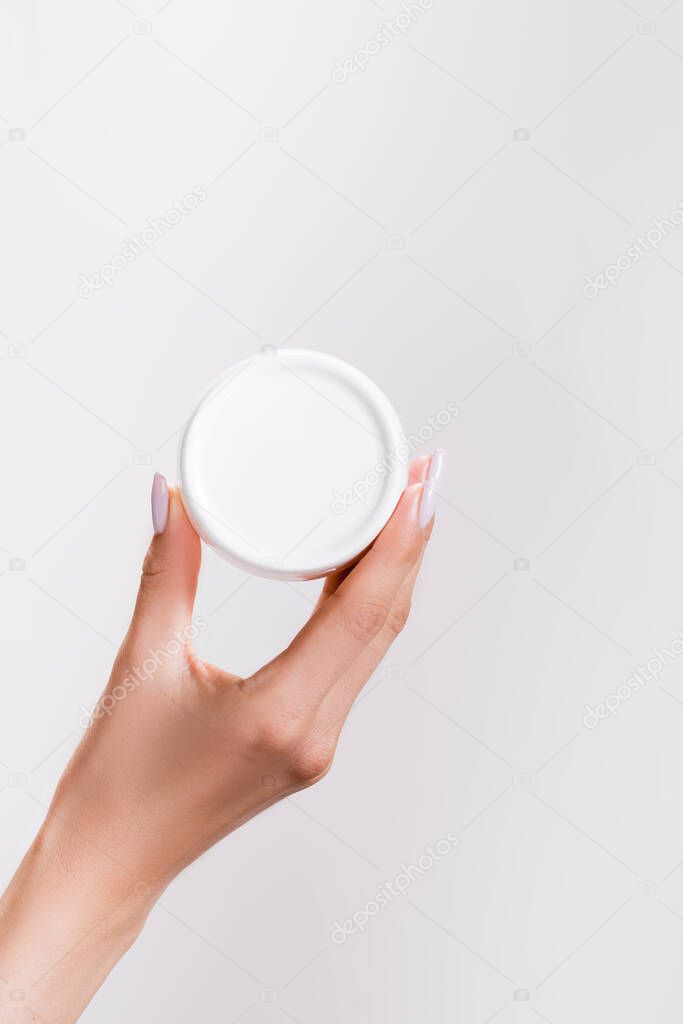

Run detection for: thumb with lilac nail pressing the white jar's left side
[[132, 473, 202, 640]]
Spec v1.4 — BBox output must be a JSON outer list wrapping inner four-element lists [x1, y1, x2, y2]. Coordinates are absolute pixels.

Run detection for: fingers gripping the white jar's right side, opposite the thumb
[[255, 483, 425, 709]]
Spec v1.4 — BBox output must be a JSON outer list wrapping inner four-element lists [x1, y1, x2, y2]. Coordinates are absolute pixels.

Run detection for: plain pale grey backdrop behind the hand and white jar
[[0, 0, 683, 1024]]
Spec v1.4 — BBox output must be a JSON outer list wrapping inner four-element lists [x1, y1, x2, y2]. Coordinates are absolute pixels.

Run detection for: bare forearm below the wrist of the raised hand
[[0, 815, 152, 1024]]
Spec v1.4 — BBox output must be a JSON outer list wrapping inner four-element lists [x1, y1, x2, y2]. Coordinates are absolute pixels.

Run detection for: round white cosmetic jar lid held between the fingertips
[[180, 347, 408, 580]]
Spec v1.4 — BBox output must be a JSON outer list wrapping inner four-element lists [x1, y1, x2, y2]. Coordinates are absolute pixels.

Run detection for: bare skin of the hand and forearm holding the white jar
[[0, 457, 444, 1024]]
